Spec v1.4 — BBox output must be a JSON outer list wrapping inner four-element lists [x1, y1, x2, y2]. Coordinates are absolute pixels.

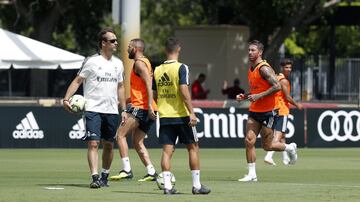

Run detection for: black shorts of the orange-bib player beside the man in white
[[127, 105, 154, 133]]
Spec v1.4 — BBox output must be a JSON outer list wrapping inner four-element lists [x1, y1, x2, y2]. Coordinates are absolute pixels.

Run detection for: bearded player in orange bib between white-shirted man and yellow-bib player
[[110, 39, 157, 181]]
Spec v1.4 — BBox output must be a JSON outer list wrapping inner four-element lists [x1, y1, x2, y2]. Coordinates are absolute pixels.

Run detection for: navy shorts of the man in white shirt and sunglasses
[[83, 111, 119, 141]]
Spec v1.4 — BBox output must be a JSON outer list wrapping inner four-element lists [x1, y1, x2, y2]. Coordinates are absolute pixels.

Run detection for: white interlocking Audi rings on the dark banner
[[317, 110, 360, 142]]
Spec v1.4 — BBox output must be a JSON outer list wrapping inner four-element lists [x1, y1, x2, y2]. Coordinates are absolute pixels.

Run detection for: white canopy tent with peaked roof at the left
[[0, 28, 84, 96]]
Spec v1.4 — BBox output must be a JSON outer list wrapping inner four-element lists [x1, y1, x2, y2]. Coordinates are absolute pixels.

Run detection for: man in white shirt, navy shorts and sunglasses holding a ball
[[63, 28, 126, 188]]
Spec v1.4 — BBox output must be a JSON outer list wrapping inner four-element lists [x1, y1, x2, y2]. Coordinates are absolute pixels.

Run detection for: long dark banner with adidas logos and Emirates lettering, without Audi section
[[0, 106, 304, 148]]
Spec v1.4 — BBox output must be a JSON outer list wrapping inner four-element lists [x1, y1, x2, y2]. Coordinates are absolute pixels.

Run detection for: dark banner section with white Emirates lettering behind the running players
[[187, 107, 304, 148]]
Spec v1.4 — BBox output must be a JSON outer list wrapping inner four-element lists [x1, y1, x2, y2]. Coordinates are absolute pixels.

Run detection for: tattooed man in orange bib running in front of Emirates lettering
[[236, 40, 297, 182]]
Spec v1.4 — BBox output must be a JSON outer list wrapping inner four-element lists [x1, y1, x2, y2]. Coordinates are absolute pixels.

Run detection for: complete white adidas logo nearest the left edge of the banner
[[13, 112, 44, 139]]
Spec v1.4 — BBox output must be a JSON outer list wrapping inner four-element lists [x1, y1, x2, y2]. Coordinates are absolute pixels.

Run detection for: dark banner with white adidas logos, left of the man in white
[[0, 106, 86, 148]]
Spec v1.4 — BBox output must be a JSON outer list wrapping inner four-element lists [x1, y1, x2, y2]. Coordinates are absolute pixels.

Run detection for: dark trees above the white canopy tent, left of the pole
[[0, 0, 112, 55]]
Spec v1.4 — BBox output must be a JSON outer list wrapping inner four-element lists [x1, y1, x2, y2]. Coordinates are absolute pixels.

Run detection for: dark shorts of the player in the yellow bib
[[159, 124, 199, 145]]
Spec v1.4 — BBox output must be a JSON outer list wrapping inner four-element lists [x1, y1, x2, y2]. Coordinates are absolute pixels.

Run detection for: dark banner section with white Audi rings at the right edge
[[307, 108, 360, 147]]
